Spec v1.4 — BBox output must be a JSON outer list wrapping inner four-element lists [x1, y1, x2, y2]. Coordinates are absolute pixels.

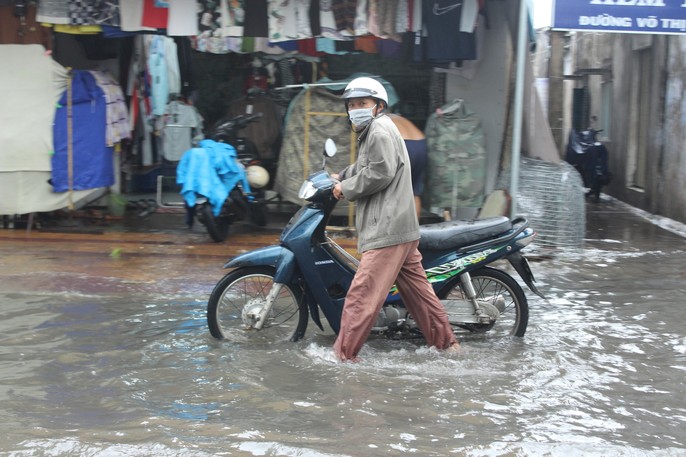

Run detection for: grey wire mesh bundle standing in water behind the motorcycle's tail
[[498, 158, 586, 249]]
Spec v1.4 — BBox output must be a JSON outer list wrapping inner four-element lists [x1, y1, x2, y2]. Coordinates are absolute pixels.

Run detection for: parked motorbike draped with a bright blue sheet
[[177, 113, 269, 242]]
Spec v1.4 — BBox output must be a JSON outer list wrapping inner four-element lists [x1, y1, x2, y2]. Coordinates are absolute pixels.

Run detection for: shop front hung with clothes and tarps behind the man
[[0, 0, 559, 227]]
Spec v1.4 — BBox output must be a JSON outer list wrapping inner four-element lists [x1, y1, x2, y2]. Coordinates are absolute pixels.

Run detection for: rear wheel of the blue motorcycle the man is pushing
[[438, 267, 529, 337]]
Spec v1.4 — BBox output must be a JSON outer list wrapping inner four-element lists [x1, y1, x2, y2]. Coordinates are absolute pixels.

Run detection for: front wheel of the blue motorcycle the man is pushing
[[207, 267, 309, 343]]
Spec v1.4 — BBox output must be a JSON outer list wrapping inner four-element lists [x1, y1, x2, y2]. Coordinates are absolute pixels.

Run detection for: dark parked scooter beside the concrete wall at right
[[565, 128, 612, 202]]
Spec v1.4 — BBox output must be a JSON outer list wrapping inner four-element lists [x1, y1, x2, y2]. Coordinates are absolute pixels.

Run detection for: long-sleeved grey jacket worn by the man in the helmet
[[339, 114, 419, 252]]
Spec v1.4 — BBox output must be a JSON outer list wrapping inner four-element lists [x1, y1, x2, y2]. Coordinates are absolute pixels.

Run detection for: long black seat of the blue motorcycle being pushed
[[419, 216, 512, 250]]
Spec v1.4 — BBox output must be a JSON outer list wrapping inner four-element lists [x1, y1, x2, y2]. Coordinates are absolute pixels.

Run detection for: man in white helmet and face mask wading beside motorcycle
[[333, 77, 460, 361]]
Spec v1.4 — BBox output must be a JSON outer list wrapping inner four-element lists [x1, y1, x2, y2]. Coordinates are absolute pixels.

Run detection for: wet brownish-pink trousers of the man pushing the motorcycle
[[334, 241, 456, 361]]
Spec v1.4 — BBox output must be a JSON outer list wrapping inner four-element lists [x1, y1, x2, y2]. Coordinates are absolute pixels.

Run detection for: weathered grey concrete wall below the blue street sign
[[569, 33, 686, 222]]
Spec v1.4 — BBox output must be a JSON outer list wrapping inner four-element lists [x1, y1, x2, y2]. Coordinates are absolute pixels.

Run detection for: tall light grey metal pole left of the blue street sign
[[510, 0, 529, 218]]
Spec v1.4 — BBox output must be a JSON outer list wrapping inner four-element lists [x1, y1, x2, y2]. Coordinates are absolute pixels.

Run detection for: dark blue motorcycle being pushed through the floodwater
[[207, 140, 543, 341]]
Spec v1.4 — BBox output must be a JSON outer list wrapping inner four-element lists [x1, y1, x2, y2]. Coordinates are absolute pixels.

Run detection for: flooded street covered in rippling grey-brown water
[[0, 200, 686, 457]]
